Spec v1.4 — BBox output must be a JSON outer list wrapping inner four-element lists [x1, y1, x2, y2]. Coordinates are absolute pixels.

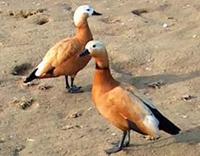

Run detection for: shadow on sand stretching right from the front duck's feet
[[125, 126, 200, 152]]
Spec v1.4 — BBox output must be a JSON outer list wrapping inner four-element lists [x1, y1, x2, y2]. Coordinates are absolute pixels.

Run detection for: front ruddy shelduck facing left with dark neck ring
[[80, 41, 180, 154]]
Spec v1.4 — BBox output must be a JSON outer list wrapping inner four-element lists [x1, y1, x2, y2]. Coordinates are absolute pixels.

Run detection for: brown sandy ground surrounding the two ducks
[[0, 0, 200, 156]]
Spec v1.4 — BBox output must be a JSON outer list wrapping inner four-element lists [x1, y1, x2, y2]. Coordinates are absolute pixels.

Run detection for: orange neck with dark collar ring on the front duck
[[93, 64, 119, 93]]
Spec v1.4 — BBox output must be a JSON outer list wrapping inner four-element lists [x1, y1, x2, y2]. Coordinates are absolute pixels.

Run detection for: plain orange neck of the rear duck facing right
[[76, 20, 93, 46]]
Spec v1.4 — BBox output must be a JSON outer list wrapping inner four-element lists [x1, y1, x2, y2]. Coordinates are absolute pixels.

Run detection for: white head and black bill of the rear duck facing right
[[74, 5, 101, 26]]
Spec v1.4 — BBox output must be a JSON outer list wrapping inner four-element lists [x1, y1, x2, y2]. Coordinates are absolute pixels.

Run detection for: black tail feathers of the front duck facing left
[[146, 104, 181, 135]]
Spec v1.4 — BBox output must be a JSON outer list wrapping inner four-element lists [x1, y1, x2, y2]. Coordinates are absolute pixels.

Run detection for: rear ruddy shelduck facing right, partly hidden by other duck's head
[[24, 5, 101, 93]]
